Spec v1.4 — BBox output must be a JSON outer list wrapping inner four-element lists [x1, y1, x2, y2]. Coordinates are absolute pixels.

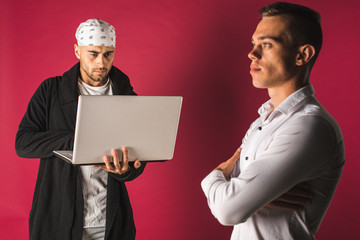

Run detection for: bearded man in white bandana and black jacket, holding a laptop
[[15, 19, 145, 240]]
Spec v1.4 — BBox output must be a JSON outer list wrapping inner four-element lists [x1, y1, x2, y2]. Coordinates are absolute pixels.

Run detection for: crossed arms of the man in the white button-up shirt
[[201, 117, 334, 225]]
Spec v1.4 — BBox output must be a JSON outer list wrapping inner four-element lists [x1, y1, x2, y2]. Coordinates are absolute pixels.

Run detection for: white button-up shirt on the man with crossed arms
[[201, 85, 345, 240]]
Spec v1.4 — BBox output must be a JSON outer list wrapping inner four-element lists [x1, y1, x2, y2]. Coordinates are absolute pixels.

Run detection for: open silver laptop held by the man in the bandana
[[54, 95, 183, 165]]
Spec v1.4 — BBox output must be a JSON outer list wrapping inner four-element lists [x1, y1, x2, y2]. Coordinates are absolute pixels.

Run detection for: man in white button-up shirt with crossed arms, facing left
[[201, 2, 345, 240]]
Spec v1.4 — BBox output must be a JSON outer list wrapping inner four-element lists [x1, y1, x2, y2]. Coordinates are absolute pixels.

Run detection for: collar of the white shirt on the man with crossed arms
[[258, 85, 315, 120]]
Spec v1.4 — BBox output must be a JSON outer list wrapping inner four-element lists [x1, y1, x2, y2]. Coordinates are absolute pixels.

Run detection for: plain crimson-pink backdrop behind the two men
[[0, 0, 360, 240]]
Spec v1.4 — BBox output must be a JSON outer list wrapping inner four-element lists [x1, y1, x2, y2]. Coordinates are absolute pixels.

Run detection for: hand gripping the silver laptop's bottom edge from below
[[95, 147, 141, 175]]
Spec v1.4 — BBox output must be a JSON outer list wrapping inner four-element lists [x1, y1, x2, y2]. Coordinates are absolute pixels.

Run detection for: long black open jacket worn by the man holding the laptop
[[15, 63, 145, 240]]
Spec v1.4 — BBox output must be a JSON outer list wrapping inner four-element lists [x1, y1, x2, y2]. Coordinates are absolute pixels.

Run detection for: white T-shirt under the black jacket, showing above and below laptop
[[78, 79, 113, 228]]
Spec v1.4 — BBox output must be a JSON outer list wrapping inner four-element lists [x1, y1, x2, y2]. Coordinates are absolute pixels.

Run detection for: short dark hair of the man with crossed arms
[[259, 2, 323, 67]]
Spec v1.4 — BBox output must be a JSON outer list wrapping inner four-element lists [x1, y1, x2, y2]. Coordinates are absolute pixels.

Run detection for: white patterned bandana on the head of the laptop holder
[[75, 19, 116, 47]]
